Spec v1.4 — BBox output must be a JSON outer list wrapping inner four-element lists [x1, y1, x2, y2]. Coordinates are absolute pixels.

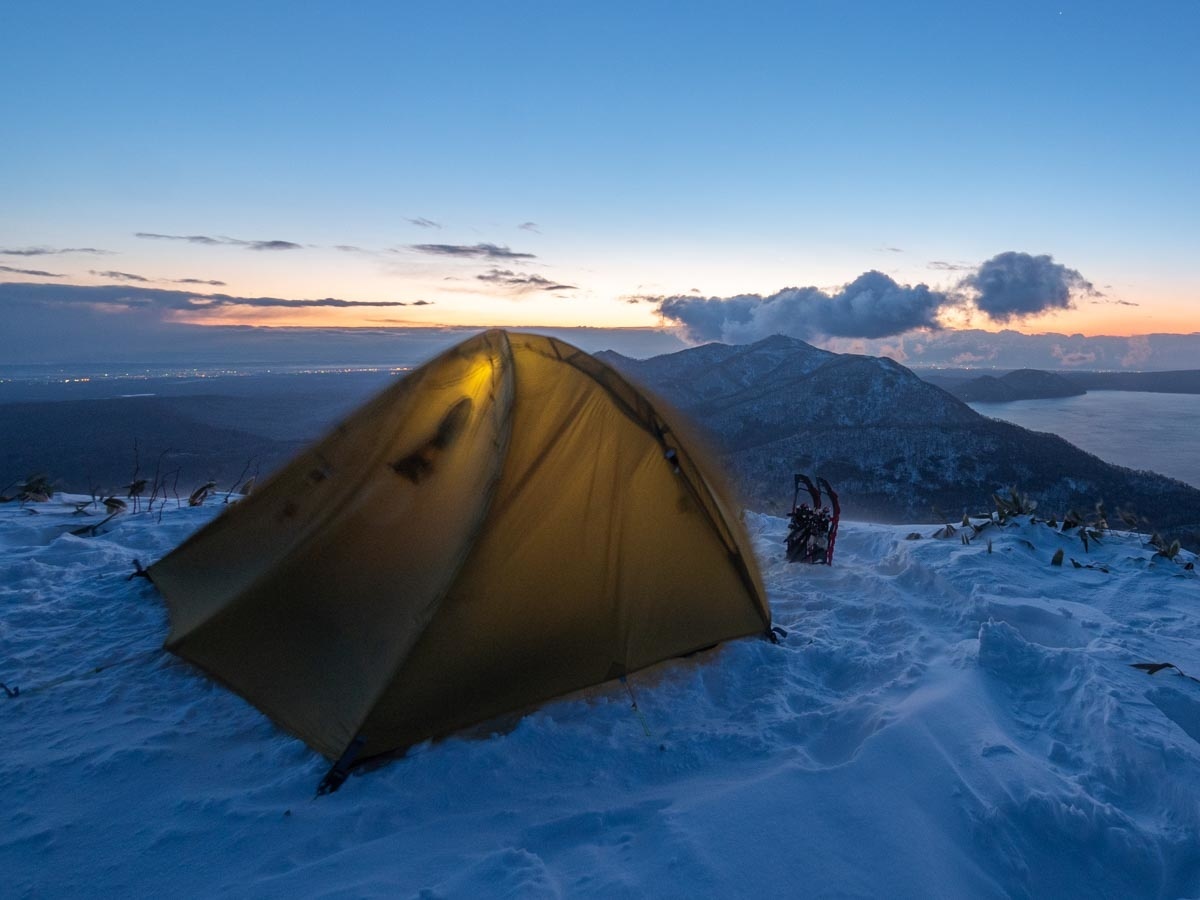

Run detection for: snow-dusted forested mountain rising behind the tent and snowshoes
[[598, 336, 1200, 540]]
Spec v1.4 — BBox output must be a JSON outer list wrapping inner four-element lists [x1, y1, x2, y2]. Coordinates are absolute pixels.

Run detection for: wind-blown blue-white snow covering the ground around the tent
[[0, 498, 1200, 898]]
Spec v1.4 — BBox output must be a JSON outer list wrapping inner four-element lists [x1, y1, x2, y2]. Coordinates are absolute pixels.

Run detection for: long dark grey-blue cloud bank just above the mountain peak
[[659, 271, 958, 343]]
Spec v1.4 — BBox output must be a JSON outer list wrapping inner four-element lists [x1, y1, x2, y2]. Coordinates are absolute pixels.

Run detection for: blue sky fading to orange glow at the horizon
[[0, 0, 1200, 337]]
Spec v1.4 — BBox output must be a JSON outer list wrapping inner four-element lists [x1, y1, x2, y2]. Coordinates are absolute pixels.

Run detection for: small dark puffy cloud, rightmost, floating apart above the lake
[[960, 251, 1098, 322]]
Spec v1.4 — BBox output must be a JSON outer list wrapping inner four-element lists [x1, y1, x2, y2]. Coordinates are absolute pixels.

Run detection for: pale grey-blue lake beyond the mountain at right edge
[[970, 391, 1200, 487]]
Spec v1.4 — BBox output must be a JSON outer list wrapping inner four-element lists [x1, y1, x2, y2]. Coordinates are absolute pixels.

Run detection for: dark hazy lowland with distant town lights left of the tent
[[0, 372, 394, 496]]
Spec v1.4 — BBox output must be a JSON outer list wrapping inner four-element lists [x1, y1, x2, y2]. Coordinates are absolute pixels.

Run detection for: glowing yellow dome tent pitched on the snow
[[149, 331, 770, 758]]
